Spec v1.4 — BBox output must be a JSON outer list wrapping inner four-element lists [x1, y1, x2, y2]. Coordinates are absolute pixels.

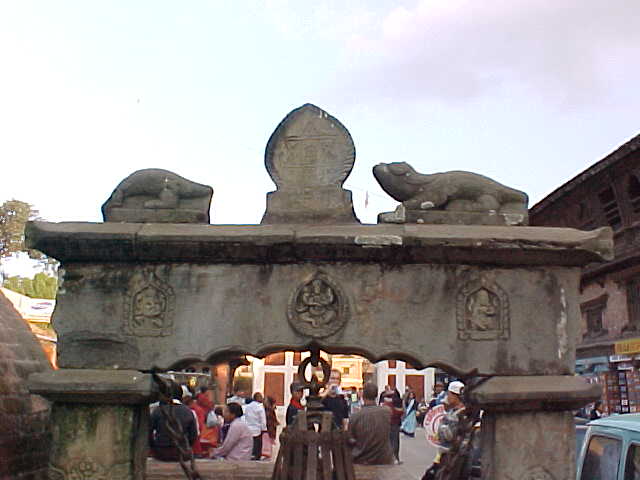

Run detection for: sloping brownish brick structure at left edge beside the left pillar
[[0, 293, 51, 480]]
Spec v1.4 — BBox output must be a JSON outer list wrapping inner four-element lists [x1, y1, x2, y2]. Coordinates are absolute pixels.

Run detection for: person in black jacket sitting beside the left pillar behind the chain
[[149, 386, 198, 462]]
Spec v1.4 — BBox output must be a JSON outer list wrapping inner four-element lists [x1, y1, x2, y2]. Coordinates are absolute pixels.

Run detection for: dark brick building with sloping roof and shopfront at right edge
[[529, 135, 640, 412]]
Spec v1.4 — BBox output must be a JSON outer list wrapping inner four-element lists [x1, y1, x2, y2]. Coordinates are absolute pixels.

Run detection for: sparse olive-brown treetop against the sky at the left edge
[[0, 199, 43, 259]]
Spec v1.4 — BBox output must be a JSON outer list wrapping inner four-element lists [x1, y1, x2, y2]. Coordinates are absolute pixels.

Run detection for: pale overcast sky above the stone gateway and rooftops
[[0, 0, 640, 223]]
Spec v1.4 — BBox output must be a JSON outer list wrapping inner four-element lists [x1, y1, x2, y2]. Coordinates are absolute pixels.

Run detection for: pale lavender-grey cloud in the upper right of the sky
[[338, 0, 640, 106]]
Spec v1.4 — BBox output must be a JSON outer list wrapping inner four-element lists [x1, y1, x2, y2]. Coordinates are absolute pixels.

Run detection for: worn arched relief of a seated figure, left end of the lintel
[[124, 267, 175, 337]]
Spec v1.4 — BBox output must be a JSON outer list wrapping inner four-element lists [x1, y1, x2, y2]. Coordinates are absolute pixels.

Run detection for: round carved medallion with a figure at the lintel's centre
[[287, 273, 350, 338]]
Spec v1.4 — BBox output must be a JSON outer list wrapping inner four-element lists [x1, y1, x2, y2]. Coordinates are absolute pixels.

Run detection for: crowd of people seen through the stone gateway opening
[[150, 370, 472, 478]]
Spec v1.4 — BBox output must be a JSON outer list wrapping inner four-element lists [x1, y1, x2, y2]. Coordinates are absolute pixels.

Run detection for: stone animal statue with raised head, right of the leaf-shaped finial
[[373, 162, 529, 225]]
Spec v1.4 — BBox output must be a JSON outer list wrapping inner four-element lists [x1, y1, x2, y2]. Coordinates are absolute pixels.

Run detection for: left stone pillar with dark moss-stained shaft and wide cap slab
[[29, 369, 153, 480]]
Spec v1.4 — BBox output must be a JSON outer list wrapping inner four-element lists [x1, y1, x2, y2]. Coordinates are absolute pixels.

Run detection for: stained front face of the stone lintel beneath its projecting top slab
[[53, 262, 580, 375]]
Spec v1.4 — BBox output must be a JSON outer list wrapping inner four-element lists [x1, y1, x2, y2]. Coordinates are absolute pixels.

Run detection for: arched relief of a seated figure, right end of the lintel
[[456, 278, 510, 340]]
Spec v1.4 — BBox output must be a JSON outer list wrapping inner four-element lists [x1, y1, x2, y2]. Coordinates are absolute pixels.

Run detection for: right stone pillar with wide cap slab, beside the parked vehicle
[[470, 376, 600, 480]]
